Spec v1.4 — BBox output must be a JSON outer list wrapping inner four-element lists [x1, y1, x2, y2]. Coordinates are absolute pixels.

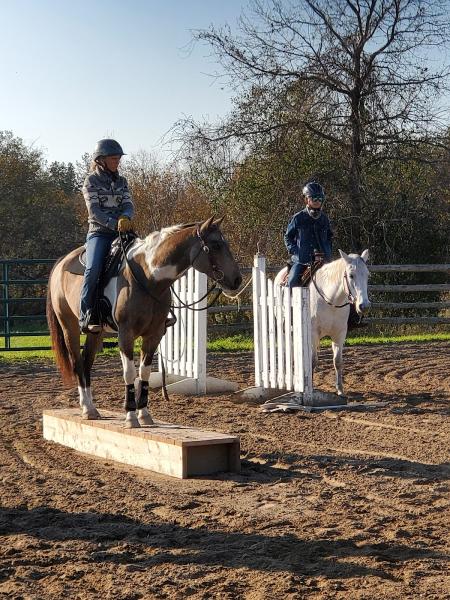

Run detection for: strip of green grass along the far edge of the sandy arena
[[0, 333, 450, 362]]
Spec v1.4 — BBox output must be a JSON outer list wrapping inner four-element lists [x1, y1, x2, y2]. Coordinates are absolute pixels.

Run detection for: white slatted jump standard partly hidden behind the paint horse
[[150, 269, 238, 395]]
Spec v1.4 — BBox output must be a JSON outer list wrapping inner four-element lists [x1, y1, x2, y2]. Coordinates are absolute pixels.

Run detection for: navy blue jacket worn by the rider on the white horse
[[284, 207, 333, 264]]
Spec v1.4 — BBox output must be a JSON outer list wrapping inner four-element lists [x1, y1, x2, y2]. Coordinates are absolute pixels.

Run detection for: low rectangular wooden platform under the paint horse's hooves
[[43, 408, 241, 479]]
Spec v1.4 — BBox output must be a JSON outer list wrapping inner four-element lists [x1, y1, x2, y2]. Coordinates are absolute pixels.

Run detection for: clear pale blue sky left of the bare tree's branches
[[0, 0, 246, 162]]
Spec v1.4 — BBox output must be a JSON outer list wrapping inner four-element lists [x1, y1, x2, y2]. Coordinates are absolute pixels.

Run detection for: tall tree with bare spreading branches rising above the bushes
[[176, 0, 450, 250]]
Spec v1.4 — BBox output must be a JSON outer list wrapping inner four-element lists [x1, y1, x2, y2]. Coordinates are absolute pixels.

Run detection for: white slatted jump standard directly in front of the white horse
[[253, 255, 313, 400]]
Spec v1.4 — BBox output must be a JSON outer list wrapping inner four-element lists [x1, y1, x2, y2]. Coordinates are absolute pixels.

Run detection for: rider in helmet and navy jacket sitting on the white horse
[[284, 181, 333, 288]]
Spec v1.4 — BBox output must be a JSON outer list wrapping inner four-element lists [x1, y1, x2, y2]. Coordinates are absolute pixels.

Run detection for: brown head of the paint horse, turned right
[[190, 217, 242, 290]]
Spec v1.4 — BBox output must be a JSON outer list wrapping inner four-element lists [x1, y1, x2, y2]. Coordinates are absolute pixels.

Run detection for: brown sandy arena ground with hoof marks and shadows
[[0, 343, 450, 600]]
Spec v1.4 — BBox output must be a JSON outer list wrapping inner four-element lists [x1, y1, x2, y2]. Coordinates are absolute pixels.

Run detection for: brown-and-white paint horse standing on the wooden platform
[[47, 217, 242, 428]]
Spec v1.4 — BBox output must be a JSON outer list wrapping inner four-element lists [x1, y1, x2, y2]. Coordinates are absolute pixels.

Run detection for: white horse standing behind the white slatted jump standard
[[274, 250, 370, 396]]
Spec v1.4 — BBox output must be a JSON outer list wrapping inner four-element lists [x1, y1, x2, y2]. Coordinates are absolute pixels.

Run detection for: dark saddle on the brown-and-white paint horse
[[67, 232, 137, 331]]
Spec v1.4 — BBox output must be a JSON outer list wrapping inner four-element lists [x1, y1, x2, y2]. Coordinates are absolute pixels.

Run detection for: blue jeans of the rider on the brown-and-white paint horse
[[80, 231, 117, 323]]
